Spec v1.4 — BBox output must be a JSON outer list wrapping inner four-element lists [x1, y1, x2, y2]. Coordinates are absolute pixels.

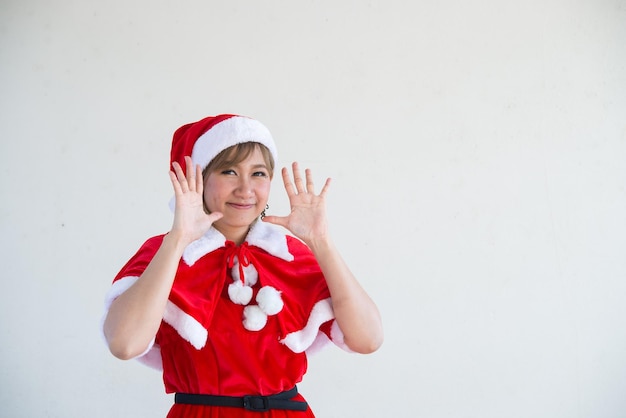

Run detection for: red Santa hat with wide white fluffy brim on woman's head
[[170, 114, 278, 175]]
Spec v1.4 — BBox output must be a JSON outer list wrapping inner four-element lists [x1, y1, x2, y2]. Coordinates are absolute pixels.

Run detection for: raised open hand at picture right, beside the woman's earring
[[263, 162, 330, 245]]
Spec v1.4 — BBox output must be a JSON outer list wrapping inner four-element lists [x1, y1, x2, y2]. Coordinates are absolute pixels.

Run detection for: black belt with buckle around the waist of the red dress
[[174, 386, 307, 412]]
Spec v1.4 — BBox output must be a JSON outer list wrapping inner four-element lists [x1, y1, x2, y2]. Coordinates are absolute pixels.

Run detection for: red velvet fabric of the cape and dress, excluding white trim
[[108, 230, 332, 418]]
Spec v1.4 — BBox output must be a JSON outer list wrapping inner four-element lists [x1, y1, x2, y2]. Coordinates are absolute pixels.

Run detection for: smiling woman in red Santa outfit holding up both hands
[[103, 115, 383, 418]]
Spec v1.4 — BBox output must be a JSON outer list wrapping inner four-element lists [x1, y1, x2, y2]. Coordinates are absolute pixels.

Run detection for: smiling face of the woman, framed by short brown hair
[[204, 147, 271, 242]]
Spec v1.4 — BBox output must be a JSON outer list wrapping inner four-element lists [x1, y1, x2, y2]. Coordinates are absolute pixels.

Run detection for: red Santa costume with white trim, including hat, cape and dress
[[100, 115, 349, 418]]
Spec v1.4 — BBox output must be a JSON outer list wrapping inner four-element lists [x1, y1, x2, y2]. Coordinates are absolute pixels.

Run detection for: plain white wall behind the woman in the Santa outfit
[[0, 0, 626, 418]]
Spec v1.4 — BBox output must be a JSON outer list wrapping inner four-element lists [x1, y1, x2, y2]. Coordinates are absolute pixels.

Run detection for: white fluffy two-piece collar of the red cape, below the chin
[[183, 221, 294, 266]]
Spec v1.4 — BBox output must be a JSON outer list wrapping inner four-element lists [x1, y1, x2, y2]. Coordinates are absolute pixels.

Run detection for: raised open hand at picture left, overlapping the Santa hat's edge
[[169, 157, 223, 245]]
